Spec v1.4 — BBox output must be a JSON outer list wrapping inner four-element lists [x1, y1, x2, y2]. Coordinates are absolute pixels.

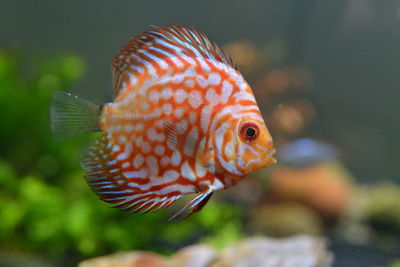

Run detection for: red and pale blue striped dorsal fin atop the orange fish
[[112, 24, 237, 96]]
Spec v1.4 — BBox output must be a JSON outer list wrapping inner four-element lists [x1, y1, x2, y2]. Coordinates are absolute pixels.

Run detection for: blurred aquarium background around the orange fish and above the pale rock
[[0, 0, 400, 266]]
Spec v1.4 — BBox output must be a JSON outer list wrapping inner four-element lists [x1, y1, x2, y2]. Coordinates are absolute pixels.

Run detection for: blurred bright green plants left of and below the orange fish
[[0, 50, 240, 262]]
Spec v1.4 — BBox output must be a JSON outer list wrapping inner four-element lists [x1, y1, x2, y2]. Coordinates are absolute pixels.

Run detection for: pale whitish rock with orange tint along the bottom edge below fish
[[79, 235, 333, 267]]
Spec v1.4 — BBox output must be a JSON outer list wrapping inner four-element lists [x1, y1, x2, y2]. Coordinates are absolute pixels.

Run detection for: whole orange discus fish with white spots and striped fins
[[51, 25, 275, 221]]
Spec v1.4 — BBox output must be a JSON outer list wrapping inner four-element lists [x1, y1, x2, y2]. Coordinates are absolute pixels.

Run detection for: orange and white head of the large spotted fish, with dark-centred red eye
[[214, 111, 276, 180]]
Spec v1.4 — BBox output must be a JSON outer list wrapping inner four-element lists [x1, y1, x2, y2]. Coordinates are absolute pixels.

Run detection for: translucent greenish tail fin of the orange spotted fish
[[50, 92, 101, 140]]
